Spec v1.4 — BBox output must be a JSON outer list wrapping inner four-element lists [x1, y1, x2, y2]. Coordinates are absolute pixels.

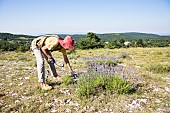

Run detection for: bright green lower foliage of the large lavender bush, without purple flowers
[[77, 73, 132, 98]]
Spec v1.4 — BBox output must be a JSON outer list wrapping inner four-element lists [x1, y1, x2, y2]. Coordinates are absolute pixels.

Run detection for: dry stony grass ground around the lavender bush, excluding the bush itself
[[0, 47, 170, 113]]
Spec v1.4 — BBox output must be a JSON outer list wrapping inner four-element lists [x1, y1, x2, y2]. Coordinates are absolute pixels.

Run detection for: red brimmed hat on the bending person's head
[[59, 36, 75, 50]]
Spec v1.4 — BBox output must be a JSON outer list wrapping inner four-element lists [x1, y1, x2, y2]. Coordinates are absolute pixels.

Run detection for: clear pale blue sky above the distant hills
[[0, 0, 170, 35]]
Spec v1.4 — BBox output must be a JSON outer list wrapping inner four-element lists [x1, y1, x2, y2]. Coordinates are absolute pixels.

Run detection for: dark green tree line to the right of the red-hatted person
[[76, 32, 170, 49]]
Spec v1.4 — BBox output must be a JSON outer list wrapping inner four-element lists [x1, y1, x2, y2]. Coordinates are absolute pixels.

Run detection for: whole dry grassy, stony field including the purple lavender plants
[[0, 47, 170, 113]]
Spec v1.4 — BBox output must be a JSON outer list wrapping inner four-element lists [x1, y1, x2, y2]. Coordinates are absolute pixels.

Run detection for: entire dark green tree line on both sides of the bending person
[[0, 32, 170, 52]]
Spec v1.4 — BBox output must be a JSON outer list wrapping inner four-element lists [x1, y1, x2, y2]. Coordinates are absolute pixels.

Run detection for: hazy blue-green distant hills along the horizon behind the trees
[[0, 32, 170, 41]]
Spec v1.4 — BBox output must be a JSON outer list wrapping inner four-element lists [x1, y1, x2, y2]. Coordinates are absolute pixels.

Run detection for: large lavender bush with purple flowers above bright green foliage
[[77, 53, 139, 98]]
